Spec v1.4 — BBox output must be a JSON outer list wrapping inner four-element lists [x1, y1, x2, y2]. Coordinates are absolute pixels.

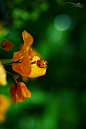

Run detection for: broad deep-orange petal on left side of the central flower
[[12, 50, 31, 76]]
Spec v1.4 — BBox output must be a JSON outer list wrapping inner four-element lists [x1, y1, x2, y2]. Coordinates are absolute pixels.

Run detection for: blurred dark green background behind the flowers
[[0, 0, 86, 129]]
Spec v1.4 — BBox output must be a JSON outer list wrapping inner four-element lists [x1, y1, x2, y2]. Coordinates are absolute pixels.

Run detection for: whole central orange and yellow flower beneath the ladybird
[[12, 31, 46, 78]]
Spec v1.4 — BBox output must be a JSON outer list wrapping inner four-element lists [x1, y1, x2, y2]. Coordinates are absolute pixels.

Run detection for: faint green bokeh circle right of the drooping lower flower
[[31, 91, 45, 104]]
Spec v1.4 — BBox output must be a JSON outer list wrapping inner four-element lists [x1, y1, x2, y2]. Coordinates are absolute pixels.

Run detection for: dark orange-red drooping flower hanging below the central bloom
[[10, 82, 31, 104]]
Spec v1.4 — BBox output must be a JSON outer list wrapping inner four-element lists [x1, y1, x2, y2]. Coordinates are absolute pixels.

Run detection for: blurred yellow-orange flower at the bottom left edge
[[0, 94, 11, 122]]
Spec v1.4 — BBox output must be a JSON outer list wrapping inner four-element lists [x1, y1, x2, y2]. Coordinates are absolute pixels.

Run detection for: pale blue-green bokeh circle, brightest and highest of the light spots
[[54, 14, 71, 31]]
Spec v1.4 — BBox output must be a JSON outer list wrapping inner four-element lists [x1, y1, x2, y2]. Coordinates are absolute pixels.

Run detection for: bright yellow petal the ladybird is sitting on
[[28, 56, 46, 78]]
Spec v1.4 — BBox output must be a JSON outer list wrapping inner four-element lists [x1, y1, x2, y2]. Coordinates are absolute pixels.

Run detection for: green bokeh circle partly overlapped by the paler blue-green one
[[46, 25, 62, 42]]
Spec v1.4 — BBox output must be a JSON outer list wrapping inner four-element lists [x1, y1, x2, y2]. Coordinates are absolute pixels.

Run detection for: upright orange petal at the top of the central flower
[[22, 30, 33, 50]]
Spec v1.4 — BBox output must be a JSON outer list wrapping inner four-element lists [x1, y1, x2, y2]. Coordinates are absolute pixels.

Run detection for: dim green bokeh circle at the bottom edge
[[19, 115, 34, 129]]
